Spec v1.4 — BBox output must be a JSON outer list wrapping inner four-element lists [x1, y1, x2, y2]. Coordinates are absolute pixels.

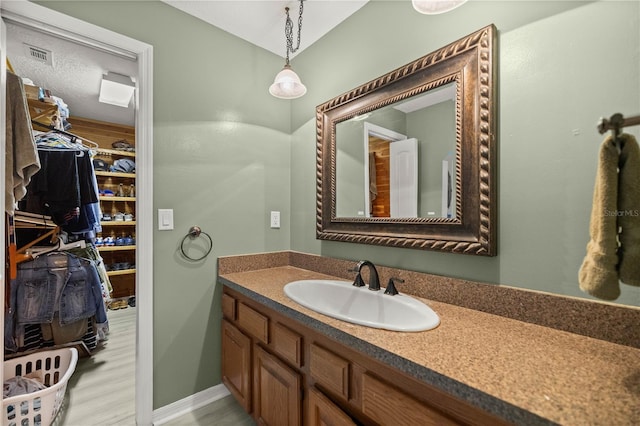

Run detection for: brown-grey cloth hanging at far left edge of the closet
[[5, 71, 40, 214]]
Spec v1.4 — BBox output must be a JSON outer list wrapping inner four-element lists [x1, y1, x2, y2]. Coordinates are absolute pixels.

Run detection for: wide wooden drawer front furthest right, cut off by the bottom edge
[[362, 373, 458, 426]]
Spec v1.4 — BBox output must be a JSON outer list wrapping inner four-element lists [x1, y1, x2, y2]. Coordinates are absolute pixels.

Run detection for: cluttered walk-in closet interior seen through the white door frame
[[0, 15, 140, 425]]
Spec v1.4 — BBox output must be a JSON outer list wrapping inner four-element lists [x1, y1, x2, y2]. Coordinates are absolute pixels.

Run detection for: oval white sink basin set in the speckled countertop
[[284, 280, 440, 331]]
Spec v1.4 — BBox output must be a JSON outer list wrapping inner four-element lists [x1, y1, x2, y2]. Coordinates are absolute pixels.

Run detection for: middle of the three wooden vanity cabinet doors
[[253, 346, 302, 426]]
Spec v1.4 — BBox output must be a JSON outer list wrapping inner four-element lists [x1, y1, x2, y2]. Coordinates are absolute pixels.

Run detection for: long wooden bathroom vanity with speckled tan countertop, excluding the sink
[[218, 252, 640, 425]]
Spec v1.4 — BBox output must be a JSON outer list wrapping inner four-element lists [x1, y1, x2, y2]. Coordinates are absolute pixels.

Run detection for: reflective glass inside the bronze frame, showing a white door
[[336, 82, 459, 218]]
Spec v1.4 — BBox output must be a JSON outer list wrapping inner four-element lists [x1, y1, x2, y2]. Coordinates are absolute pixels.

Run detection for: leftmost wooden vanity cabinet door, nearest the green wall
[[222, 320, 251, 413]]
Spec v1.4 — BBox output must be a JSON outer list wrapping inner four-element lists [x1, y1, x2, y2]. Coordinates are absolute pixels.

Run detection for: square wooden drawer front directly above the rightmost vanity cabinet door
[[309, 344, 349, 399]]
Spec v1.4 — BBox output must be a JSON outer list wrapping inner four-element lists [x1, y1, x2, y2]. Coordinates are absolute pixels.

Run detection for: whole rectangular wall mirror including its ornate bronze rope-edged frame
[[316, 25, 497, 256]]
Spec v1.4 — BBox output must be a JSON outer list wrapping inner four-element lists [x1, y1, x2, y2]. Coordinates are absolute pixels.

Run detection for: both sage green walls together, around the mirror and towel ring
[[35, 0, 640, 408]]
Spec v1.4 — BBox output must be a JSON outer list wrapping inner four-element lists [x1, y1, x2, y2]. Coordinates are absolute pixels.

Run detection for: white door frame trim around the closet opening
[[0, 2, 153, 425]]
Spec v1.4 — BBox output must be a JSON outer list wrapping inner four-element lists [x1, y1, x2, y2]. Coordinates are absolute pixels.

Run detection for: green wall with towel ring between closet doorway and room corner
[[35, 1, 291, 408]]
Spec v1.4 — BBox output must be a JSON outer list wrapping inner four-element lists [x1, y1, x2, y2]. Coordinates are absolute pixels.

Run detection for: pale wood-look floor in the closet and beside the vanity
[[54, 307, 255, 426]]
